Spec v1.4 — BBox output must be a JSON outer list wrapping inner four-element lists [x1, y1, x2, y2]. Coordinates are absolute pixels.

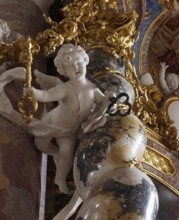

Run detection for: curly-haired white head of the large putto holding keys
[[54, 44, 89, 77]]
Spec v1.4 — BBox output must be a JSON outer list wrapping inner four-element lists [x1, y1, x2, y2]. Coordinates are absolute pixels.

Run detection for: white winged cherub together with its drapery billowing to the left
[[0, 44, 112, 193]]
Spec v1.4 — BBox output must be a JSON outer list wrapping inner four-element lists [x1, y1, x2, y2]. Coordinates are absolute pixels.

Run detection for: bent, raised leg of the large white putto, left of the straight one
[[34, 136, 59, 156]]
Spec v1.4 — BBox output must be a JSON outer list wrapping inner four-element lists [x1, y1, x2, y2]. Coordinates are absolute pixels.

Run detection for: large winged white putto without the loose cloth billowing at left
[[32, 44, 110, 193]]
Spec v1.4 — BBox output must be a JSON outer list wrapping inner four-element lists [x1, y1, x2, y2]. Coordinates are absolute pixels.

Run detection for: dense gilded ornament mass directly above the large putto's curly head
[[60, 0, 138, 59]]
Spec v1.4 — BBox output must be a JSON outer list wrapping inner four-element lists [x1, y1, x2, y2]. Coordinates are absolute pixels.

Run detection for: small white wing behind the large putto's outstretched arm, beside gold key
[[34, 70, 61, 90]]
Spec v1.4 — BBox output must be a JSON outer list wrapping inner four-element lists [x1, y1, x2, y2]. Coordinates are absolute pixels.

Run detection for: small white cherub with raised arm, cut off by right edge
[[159, 63, 179, 97]]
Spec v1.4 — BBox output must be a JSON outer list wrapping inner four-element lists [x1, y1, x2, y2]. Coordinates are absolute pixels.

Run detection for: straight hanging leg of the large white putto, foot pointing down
[[54, 137, 76, 193]]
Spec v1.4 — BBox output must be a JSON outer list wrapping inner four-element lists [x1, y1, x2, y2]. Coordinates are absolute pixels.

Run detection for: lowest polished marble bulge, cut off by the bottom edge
[[76, 167, 158, 220]]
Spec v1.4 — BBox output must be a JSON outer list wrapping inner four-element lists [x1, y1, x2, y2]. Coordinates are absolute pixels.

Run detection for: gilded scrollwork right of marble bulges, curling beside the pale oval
[[133, 61, 179, 151]]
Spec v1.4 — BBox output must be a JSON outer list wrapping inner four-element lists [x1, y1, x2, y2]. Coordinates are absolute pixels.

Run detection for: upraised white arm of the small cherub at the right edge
[[159, 63, 171, 96]]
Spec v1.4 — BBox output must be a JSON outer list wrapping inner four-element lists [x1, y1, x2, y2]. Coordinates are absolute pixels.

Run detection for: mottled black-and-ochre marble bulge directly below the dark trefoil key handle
[[74, 114, 146, 200]]
